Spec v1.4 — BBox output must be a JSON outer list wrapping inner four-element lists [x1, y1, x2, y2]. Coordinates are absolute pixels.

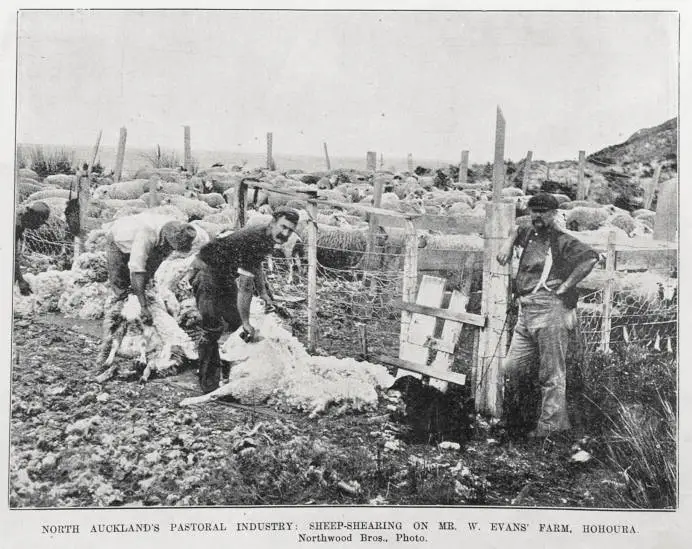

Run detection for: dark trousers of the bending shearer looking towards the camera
[[190, 259, 243, 393]]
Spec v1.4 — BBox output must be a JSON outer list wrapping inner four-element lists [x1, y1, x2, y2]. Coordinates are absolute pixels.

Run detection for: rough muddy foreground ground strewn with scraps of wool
[[10, 316, 625, 507]]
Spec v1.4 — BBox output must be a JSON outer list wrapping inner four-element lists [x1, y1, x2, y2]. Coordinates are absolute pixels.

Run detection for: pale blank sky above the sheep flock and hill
[[16, 10, 678, 162]]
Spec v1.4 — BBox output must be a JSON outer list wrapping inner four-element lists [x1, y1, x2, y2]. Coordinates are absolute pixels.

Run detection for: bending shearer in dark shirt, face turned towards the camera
[[189, 208, 299, 393]]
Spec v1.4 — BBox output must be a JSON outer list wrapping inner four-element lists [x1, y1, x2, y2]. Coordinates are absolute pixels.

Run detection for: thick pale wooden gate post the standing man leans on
[[473, 202, 515, 417]]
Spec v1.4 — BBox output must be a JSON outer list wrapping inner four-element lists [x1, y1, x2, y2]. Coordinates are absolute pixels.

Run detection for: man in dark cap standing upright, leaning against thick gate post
[[497, 193, 598, 438]]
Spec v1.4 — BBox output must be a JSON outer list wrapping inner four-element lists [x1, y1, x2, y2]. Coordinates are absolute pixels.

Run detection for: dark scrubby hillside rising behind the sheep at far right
[[588, 117, 678, 166]]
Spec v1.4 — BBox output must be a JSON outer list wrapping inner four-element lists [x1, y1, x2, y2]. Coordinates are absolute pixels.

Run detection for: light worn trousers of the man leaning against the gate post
[[504, 291, 576, 435]]
